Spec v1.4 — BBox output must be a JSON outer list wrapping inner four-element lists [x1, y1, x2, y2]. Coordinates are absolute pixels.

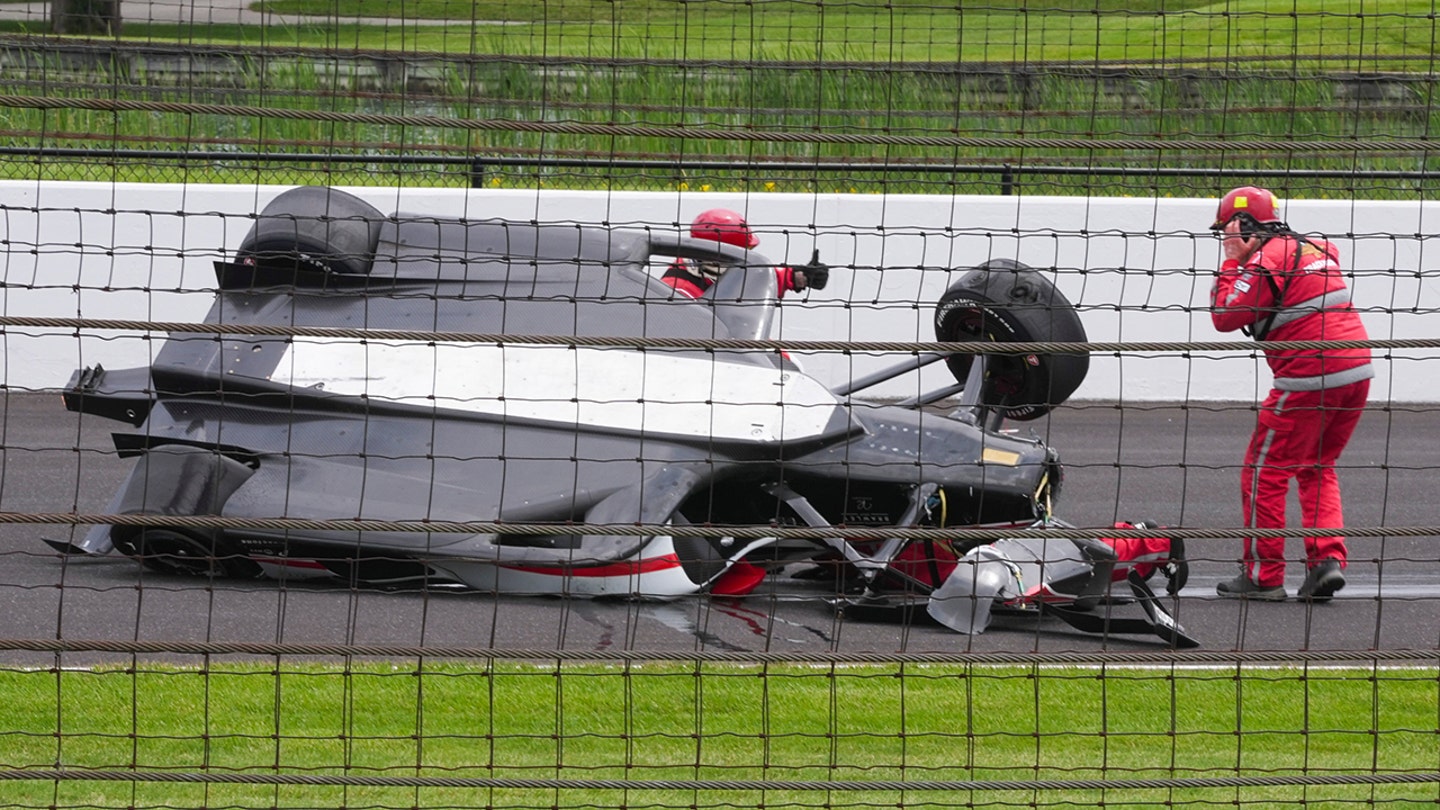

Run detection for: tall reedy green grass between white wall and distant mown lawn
[[11, 65, 1440, 199]]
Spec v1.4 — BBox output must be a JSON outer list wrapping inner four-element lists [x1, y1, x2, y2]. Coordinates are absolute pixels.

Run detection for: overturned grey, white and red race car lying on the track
[[48, 186, 1195, 646]]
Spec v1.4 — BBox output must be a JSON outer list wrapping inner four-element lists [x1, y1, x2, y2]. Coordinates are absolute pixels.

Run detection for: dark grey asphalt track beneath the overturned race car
[[0, 392, 1440, 666]]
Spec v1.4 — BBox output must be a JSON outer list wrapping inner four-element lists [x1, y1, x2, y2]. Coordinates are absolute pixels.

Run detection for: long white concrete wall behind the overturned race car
[[0, 182, 1440, 402]]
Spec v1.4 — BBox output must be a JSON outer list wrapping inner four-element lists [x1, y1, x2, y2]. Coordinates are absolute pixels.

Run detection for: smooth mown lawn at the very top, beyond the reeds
[[73, 0, 1434, 64]]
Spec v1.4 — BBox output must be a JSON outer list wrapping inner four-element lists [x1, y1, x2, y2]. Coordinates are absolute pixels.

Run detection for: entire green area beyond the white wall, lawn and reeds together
[[0, 0, 1440, 191]]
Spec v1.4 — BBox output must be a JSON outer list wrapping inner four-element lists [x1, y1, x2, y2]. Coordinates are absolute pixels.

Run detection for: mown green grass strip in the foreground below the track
[[0, 662, 1440, 807]]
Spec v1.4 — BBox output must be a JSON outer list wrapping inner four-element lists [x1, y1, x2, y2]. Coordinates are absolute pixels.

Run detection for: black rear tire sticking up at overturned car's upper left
[[238, 186, 386, 278]]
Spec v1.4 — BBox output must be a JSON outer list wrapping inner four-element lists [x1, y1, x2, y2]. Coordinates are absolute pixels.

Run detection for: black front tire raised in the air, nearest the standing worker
[[935, 259, 1090, 421]]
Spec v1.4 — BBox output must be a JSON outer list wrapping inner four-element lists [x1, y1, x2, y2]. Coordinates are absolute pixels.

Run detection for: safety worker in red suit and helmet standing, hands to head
[[1211, 186, 1375, 602]]
